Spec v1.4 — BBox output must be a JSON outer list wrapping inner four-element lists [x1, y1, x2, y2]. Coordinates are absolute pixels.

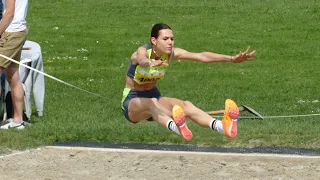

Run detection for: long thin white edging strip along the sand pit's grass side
[[45, 146, 320, 159]]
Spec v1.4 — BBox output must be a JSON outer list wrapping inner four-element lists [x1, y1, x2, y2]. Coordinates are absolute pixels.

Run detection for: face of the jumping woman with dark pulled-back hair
[[151, 29, 174, 54]]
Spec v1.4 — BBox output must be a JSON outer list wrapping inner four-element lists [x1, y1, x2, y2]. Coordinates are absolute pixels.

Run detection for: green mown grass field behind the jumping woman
[[0, 0, 320, 150]]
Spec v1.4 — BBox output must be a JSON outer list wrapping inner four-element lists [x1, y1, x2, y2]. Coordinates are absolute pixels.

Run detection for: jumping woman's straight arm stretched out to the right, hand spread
[[173, 46, 256, 63]]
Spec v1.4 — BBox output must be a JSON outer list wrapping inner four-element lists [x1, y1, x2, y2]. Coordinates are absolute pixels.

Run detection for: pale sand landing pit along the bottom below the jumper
[[0, 147, 320, 180]]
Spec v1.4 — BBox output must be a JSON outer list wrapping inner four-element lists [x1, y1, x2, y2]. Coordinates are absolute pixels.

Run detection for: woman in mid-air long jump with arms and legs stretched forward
[[121, 24, 256, 140]]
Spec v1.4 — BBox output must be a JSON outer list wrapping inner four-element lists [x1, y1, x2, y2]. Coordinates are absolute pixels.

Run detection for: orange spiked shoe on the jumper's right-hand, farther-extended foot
[[222, 99, 239, 138]]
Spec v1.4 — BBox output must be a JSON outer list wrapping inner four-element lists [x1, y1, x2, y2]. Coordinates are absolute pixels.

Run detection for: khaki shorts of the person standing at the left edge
[[0, 30, 28, 68]]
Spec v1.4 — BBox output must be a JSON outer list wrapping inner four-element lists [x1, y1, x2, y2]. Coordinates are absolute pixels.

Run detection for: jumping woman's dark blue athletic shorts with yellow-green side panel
[[121, 87, 161, 122]]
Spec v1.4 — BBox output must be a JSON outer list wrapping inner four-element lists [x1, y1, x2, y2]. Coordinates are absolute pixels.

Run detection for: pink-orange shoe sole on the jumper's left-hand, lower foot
[[172, 105, 192, 140]]
